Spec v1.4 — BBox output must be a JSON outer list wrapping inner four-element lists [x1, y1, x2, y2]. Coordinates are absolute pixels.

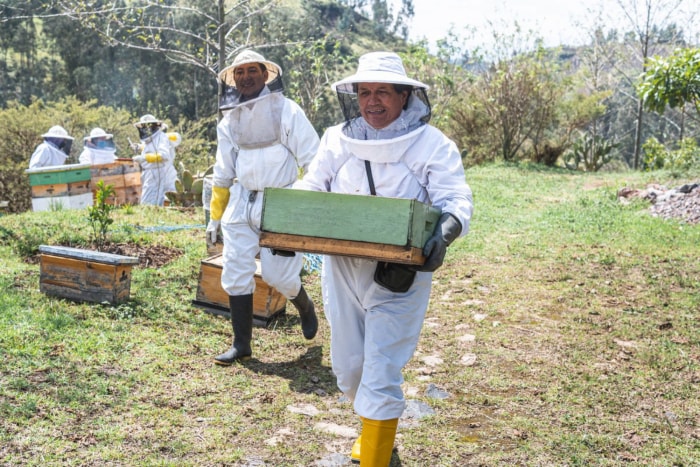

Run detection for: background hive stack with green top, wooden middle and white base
[[25, 164, 92, 211]]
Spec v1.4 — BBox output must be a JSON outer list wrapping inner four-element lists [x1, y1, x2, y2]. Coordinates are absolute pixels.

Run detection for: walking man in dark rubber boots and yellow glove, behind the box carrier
[[206, 50, 319, 365]]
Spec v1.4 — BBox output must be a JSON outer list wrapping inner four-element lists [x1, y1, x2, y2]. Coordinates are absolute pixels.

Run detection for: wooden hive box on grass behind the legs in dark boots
[[192, 254, 287, 326]]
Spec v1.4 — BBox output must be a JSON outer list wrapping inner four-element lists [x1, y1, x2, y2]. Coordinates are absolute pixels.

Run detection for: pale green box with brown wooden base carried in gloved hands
[[260, 188, 440, 264]]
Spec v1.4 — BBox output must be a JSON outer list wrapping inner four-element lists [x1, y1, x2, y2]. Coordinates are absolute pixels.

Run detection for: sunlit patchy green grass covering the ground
[[0, 165, 700, 466]]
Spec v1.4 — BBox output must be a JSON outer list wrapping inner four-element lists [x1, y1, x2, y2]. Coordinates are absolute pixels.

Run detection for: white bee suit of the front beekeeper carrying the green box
[[295, 59, 472, 424]]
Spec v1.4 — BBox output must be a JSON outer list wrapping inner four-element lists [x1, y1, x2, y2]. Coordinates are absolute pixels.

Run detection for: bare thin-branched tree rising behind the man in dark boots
[[37, 0, 276, 114]]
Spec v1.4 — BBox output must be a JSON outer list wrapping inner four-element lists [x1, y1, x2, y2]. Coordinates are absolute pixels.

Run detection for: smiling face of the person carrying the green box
[[357, 83, 408, 130]]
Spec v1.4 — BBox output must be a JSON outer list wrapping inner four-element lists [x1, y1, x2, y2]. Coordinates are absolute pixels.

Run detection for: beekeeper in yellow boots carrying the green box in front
[[295, 52, 472, 467]]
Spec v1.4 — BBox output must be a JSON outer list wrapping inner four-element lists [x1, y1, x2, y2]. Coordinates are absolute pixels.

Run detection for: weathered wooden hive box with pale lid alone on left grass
[[39, 245, 139, 304]]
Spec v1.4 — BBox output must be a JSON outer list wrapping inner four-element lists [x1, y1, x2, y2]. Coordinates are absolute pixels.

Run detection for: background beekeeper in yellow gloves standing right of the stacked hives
[[133, 114, 177, 206]]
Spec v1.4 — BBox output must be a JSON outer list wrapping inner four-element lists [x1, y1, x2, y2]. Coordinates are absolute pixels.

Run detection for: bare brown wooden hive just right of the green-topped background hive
[[90, 159, 141, 206]]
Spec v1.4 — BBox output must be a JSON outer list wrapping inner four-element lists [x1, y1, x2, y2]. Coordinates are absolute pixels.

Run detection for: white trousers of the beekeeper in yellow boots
[[322, 256, 433, 420]]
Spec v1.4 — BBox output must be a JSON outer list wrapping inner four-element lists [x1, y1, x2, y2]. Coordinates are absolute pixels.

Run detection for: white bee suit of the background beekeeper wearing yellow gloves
[[140, 130, 177, 206]]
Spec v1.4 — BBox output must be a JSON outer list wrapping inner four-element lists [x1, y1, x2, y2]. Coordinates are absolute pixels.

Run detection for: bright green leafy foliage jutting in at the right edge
[[637, 49, 700, 140]]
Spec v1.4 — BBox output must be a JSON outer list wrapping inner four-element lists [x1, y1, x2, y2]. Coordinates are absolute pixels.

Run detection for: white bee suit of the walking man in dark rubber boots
[[212, 87, 319, 298]]
